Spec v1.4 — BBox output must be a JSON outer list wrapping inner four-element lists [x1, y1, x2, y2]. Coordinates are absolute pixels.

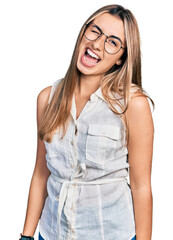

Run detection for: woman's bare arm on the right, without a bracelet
[[126, 96, 154, 240]]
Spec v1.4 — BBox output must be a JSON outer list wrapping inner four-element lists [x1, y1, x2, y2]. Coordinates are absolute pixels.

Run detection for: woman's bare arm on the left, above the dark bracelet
[[23, 87, 51, 236]]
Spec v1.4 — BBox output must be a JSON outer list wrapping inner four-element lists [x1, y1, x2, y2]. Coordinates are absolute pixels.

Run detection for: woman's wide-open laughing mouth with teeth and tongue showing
[[82, 48, 101, 67]]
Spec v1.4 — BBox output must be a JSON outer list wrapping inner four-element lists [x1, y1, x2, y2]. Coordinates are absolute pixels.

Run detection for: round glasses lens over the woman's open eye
[[105, 37, 121, 54]]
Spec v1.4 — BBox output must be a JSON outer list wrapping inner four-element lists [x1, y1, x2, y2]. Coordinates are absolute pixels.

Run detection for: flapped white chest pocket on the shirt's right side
[[86, 124, 121, 165]]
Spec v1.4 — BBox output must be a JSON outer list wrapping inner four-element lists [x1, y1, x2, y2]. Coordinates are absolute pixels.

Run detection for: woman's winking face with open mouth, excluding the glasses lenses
[[77, 13, 125, 77]]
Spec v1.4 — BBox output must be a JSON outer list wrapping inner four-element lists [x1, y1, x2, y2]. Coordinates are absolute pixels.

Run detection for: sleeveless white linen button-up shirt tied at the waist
[[39, 79, 135, 240]]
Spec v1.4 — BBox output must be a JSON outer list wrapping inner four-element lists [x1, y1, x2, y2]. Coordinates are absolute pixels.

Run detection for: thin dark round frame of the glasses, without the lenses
[[83, 22, 126, 55]]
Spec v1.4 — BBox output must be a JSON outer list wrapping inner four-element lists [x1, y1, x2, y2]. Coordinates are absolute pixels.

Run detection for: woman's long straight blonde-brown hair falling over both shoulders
[[38, 5, 153, 142]]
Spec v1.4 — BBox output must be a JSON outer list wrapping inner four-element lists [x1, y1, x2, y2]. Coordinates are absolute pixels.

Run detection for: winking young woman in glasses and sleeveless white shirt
[[21, 5, 154, 240]]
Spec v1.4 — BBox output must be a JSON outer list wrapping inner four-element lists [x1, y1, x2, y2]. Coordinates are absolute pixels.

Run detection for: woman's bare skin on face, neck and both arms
[[23, 13, 154, 240]]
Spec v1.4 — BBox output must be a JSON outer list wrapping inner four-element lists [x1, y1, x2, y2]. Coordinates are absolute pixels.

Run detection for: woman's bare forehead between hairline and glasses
[[93, 13, 125, 42]]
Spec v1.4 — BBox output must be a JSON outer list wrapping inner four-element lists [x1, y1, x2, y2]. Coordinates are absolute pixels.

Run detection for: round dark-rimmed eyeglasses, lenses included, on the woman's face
[[84, 23, 125, 54]]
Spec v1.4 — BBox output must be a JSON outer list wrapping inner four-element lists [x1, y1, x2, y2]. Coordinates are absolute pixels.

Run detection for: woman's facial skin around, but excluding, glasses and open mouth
[[77, 13, 125, 81]]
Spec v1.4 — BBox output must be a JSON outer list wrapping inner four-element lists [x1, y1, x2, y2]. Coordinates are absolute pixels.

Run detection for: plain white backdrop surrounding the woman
[[0, 0, 173, 240]]
